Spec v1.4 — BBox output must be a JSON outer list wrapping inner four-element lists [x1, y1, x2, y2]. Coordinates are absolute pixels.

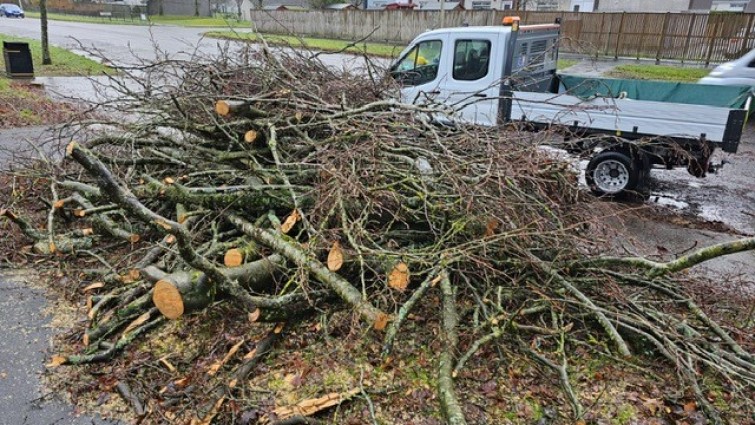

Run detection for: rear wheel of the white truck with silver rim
[[585, 151, 640, 196]]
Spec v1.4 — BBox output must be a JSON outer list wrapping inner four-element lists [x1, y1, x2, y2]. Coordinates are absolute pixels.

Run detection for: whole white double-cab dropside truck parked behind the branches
[[391, 20, 750, 196]]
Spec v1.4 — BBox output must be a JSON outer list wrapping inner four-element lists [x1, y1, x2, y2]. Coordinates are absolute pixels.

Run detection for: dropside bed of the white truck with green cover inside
[[510, 76, 750, 152]]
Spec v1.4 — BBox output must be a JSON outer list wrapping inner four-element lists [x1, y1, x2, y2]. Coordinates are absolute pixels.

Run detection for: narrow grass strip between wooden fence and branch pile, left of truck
[[205, 31, 404, 58]]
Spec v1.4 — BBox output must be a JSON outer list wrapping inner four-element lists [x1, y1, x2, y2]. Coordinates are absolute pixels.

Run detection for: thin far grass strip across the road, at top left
[[26, 12, 251, 28]]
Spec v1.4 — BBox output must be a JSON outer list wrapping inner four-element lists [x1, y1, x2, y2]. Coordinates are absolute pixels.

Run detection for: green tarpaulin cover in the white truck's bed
[[558, 74, 752, 109]]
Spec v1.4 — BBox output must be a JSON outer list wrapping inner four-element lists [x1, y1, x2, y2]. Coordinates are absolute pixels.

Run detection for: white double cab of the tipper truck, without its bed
[[391, 21, 559, 125]]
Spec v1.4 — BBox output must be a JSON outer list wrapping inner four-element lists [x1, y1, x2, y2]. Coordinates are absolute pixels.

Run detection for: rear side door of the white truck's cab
[[440, 32, 506, 125]]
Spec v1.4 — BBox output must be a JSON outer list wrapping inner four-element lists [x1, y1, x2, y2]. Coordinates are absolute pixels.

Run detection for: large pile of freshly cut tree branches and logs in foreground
[[2, 44, 755, 424]]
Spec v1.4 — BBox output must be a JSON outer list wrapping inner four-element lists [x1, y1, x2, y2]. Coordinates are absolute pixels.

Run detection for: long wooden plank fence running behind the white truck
[[251, 10, 755, 65]]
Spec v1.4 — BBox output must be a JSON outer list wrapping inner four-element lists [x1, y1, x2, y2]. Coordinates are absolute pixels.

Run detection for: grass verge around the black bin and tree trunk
[[0, 34, 110, 76]]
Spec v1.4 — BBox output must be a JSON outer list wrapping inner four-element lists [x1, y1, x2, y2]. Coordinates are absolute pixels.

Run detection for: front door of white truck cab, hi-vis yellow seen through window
[[391, 34, 449, 104]]
